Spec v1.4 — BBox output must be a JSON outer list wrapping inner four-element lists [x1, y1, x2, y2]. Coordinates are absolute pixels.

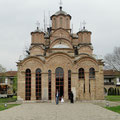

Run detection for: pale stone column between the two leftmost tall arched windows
[[31, 73, 36, 101]]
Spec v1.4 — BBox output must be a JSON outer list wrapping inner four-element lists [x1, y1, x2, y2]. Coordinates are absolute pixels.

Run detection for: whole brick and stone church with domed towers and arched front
[[17, 7, 104, 101]]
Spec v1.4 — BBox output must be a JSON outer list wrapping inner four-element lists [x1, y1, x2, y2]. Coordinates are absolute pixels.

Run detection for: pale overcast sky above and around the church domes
[[0, 0, 120, 70]]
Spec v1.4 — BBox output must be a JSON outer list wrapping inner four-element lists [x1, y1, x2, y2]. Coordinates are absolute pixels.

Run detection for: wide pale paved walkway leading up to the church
[[0, 102, 120, 120]]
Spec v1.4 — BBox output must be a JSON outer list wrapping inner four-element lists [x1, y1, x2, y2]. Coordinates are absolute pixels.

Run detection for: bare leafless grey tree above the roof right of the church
[[104, 47, 120, 71]]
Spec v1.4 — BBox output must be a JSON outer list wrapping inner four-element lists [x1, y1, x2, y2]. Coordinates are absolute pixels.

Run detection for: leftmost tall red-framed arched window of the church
[[25, 69, 31, 100]]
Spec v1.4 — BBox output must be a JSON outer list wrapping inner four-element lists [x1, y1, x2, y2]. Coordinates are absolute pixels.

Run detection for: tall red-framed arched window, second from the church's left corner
[[36, 68, 42, 100]]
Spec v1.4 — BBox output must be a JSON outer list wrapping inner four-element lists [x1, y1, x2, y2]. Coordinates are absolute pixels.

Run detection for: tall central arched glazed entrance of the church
[[55, 67, 64, 99]]
